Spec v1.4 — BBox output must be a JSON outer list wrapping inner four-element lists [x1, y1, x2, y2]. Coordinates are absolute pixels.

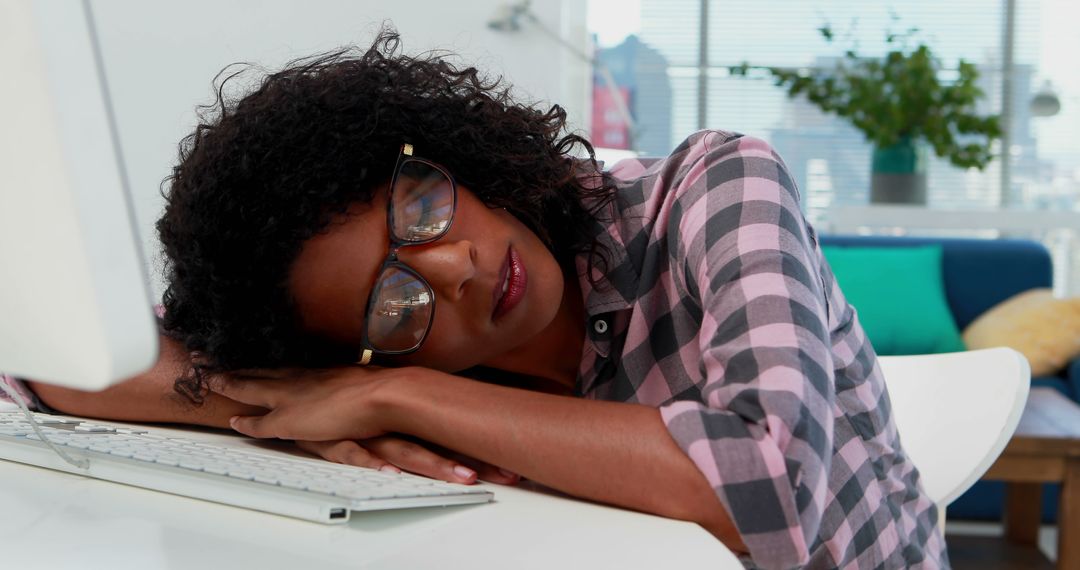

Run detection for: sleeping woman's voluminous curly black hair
[[157, 28, 613, 401]]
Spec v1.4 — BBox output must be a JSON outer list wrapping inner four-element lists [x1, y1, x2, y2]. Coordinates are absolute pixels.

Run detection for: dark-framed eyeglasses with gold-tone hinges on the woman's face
[[359, 144, 458, 366]]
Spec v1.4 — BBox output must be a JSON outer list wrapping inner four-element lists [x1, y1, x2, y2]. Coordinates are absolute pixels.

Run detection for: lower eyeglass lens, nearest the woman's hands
[[367, 267, 435, 352]]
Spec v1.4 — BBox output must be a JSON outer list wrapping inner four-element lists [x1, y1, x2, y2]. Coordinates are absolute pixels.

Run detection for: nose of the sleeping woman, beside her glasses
[[397, 239, 476, 301]]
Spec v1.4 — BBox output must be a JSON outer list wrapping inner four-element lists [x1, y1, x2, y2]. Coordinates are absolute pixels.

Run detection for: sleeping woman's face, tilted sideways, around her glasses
[[289, 184, 564, 371]]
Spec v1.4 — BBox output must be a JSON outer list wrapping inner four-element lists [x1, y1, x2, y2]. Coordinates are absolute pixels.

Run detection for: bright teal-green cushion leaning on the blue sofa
[[822, 245, 964, 354]]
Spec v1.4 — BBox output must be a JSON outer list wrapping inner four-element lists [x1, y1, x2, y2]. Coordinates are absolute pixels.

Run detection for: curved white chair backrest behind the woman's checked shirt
[[879, 348, 1031, 506]]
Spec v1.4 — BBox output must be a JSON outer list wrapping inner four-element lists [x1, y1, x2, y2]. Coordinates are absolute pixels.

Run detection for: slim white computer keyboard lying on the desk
[[0, 411, 492, 524]]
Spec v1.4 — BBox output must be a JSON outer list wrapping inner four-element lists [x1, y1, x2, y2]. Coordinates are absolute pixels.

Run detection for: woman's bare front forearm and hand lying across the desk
[[214, 367, 745, 552]]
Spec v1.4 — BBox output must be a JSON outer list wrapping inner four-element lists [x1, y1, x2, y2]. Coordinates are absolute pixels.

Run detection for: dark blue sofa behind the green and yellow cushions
[[820, 235, 1080, 523]]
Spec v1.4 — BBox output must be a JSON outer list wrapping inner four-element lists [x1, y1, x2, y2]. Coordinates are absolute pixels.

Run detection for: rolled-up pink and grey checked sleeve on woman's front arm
[[661, 133, 835, 568]]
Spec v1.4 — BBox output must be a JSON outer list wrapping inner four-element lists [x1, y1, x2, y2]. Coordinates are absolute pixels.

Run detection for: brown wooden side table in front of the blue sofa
[[983, 388, 1080, 569]]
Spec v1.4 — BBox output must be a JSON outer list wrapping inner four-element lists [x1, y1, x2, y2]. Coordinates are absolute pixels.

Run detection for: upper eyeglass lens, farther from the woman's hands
[[391, 160, 454, 242]]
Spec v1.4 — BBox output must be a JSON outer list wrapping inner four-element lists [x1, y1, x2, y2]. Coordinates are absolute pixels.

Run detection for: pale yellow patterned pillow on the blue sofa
[[963, 289, 1080, 377]]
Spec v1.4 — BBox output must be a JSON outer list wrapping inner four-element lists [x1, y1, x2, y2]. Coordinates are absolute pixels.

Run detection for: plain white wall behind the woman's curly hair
[[92, 0, 590, 298]]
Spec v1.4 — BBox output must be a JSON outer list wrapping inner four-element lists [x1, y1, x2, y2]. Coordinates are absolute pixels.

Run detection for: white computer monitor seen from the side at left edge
[[0, 0, 158, 390]]
